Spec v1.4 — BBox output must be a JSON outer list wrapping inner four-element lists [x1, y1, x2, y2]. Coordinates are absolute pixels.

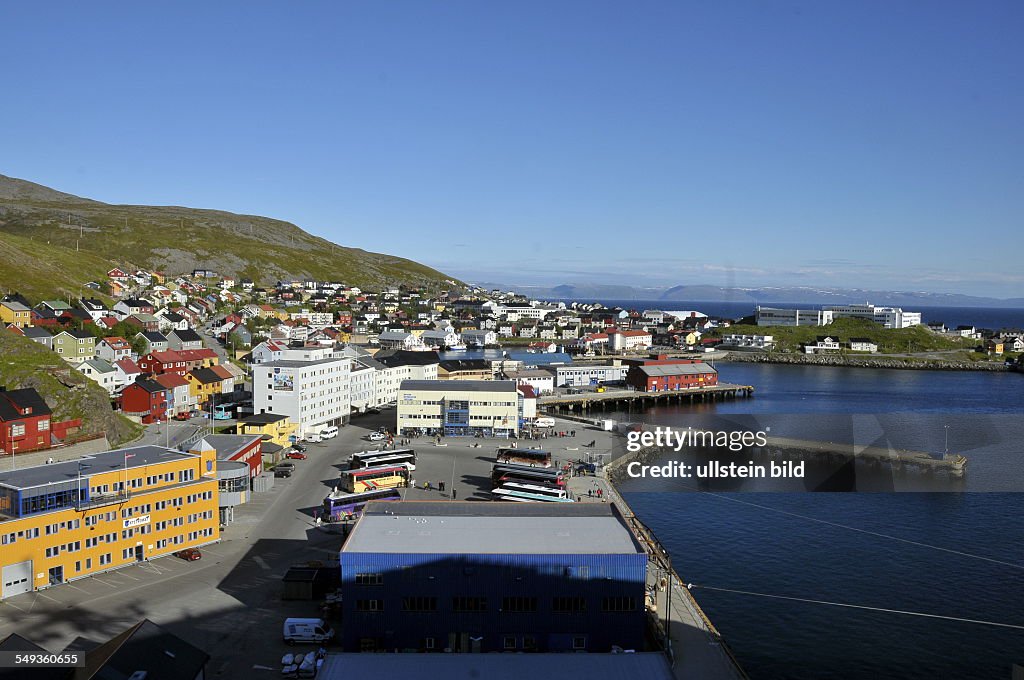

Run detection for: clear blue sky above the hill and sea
[[0, 0, 1024, 297]]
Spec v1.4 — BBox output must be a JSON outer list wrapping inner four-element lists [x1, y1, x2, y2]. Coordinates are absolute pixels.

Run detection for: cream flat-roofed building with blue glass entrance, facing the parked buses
[[396, 380, 522, 436]]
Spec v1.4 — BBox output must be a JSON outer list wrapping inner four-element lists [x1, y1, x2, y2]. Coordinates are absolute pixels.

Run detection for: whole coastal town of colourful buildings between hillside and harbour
[[0, 267, 1024, 677]]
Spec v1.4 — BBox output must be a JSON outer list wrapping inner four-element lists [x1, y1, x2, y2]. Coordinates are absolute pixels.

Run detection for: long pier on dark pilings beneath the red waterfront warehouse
[[537, 383, 754, 413]]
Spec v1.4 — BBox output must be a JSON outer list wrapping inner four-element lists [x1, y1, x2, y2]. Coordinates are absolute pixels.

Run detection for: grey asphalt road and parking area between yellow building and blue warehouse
[[0, 410, 603, 678]]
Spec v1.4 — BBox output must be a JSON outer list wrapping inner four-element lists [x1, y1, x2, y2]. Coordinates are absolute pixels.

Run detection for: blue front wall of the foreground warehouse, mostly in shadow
[[341, 552, 647, 651]]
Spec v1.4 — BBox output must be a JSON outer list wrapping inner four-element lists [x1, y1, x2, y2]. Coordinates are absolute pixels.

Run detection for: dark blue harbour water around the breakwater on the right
[[610, 363, 1024, 680]]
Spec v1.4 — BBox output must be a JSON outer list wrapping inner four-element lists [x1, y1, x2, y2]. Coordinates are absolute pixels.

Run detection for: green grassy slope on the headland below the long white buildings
[[716, 318, 966, 353]]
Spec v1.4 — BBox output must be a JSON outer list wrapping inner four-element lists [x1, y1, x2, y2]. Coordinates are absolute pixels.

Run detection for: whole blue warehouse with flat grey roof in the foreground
[[341, 501, 647, 652]]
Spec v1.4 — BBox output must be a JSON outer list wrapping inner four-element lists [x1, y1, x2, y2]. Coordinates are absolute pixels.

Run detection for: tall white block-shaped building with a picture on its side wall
[[253, 357, 352, 435]]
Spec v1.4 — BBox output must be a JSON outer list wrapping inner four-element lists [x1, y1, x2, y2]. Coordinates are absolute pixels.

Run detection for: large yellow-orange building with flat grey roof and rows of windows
[[0, 447, 220, 598]]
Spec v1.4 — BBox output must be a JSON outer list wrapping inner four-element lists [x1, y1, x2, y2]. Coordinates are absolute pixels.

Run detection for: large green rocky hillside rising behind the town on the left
[[0, 175, 449, 298]]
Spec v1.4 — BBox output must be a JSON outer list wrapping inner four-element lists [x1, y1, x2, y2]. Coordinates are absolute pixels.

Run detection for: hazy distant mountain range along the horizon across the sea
[[477, 283, 1024, 310]]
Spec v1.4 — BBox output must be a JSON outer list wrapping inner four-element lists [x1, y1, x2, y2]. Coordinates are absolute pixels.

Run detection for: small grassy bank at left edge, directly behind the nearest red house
[[0, 329, 140, 445]]
